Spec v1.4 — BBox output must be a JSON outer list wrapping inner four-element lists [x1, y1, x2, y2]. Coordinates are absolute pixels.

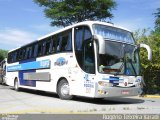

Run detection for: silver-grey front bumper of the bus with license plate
[[95, 87, 142, 98]]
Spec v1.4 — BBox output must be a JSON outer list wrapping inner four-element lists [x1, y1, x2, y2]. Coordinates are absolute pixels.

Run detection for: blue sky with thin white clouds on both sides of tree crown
[[0, 0, 160, 50]]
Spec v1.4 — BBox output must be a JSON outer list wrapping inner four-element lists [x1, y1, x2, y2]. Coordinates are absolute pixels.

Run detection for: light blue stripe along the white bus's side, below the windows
[[7, 59, 50, 72]]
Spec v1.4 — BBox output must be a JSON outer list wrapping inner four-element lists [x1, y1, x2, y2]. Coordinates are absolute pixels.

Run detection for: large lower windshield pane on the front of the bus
[[98, 40, 140, 76]]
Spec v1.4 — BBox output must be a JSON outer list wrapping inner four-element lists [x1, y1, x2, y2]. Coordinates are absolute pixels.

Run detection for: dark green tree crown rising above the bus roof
[[34, 0, 116, 27]]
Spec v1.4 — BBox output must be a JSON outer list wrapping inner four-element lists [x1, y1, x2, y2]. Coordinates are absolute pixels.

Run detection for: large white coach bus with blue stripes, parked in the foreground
[[6, 21, 152, 100]]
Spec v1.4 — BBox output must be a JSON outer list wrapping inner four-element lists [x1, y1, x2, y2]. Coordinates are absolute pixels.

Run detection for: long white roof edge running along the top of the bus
[[9, 21, 131, 52]]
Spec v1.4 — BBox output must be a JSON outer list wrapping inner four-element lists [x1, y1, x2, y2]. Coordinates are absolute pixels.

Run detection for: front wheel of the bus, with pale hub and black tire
[[57, 79, 73, 100]]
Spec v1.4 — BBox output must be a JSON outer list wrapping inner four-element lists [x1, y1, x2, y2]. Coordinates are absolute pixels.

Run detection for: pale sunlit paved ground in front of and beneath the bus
[[0, 85, 160, 114]]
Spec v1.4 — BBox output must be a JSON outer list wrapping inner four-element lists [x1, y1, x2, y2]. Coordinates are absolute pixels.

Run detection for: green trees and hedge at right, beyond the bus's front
[[134, 21, 160, 94]]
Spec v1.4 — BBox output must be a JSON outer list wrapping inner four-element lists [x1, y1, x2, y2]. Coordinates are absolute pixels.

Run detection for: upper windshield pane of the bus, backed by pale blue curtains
[[93, 24, 135, 44]]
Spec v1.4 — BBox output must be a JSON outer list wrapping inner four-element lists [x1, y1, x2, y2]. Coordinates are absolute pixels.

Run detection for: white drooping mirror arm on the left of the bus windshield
[[92, 35, 105, 54]]
